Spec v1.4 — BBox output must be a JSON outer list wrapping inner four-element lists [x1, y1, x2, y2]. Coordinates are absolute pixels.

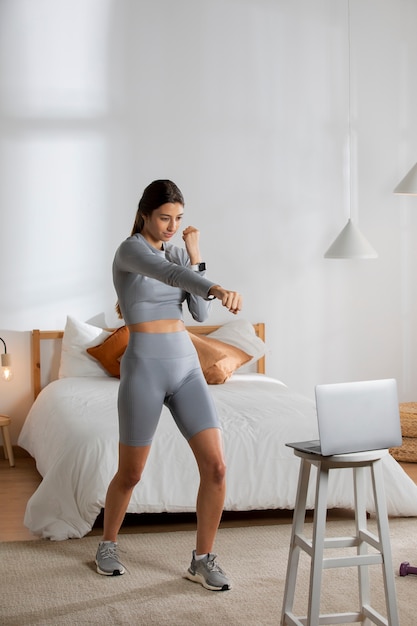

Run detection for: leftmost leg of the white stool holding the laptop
[[281, 459, 311, 626]]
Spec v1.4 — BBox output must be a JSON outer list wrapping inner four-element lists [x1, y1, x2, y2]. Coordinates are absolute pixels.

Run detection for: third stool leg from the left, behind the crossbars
[[353, 467, 371, 612]]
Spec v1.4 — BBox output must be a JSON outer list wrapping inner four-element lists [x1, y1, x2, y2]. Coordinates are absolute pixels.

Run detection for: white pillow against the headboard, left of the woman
[[58, 315, 111, 378]]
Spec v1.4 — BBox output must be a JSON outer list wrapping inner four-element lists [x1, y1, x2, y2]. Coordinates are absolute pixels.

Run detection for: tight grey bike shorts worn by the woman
[[118, 331, 220, 446]]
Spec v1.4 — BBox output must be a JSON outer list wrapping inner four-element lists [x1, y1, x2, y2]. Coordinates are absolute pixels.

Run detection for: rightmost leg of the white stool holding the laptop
[[371, 459, 399, 626]]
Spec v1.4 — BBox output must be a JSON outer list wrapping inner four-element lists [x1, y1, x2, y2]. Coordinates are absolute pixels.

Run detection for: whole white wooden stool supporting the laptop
[[281, 450, 398, 626]]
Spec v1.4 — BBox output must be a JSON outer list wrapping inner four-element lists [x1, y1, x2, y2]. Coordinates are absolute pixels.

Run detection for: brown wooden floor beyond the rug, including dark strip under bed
[[0, 456, 417, 541]]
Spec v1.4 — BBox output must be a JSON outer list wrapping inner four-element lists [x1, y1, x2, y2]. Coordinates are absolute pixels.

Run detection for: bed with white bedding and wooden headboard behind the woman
[[18, 318, 417, 540]]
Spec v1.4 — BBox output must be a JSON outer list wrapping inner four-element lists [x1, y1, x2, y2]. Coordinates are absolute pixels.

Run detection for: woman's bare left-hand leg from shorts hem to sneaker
[[103, 443, 151, 542]]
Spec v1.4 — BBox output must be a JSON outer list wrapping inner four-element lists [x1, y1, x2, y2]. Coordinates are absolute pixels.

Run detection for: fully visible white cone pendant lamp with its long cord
[[324, 0, 378, 259]]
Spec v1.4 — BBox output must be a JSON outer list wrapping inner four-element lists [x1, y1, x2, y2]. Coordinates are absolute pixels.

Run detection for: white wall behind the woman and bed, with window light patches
[[0, 0, 417, 441]]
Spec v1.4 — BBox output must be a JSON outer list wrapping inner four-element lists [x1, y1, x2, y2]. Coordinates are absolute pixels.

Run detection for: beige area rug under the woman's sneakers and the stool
[[0, 519, 417, 626]]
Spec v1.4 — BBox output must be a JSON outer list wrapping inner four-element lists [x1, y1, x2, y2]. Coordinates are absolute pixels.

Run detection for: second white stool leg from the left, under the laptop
[[307, 463, 329, 626]]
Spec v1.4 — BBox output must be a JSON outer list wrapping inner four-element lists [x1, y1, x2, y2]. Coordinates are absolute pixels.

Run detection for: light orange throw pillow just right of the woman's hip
[[188, 333, 252, 385]]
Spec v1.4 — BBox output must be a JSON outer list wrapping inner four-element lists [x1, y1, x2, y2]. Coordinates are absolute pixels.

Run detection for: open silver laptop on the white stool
[[286, 378, 402, 456]]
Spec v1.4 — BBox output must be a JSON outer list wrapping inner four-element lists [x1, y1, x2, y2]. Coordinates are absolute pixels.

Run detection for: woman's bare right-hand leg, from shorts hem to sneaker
[[189, 428, 226, 554]]
